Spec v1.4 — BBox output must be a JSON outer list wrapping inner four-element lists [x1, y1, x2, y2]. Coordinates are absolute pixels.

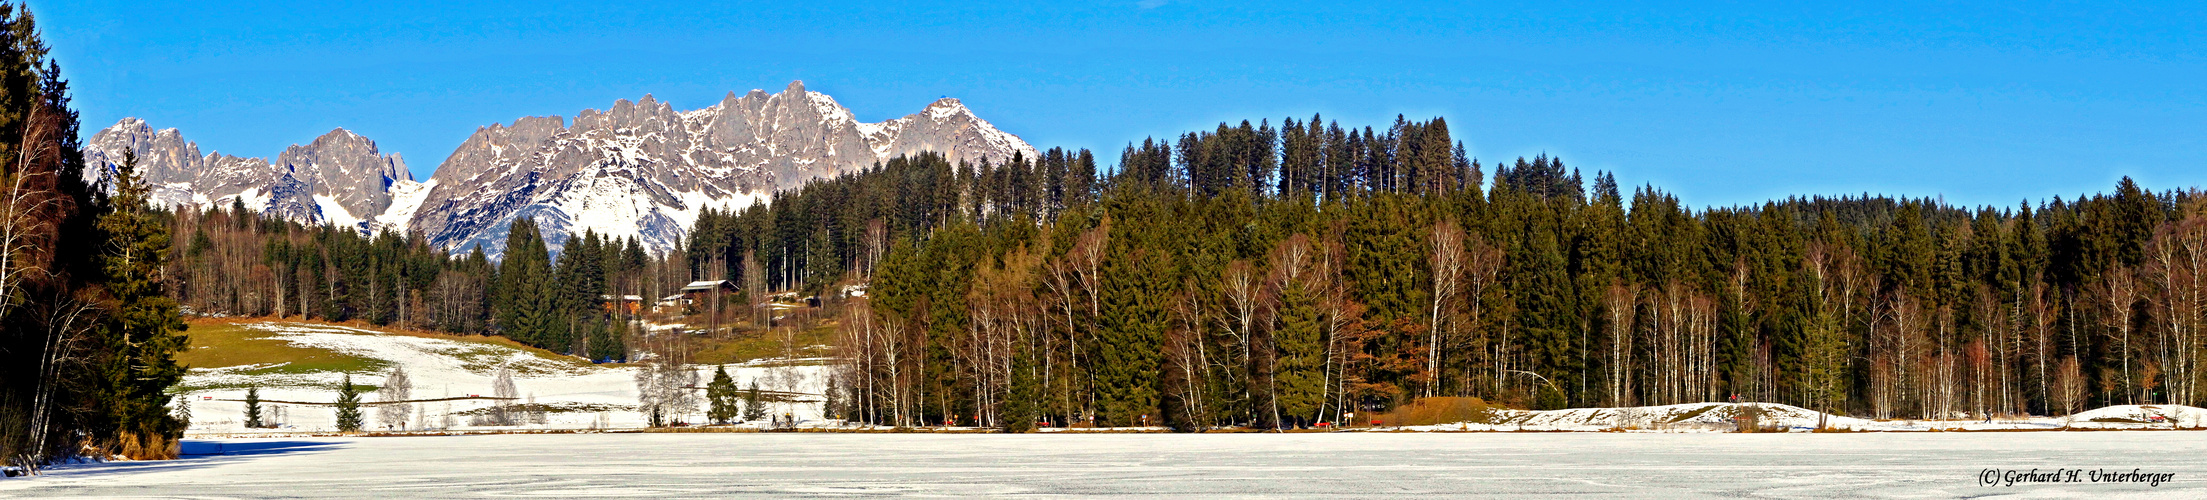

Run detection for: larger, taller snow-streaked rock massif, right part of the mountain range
[[408, 81, 1035, 256]]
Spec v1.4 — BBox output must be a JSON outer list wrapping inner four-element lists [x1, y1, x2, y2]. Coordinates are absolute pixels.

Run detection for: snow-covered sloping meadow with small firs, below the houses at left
[[179, 322, 825, 436]]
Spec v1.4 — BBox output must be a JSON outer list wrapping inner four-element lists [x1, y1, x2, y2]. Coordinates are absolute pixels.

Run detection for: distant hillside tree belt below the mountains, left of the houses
[[157, 203, 691, 361]]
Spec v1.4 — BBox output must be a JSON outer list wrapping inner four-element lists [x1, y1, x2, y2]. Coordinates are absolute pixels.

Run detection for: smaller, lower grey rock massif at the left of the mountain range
[[84, 119, 415, 231]]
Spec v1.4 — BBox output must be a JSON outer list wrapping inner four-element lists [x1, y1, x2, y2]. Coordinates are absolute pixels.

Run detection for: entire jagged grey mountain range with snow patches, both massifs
[[86, 81, 1035, 256]]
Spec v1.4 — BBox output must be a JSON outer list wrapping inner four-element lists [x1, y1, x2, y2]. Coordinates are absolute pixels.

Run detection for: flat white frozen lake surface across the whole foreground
[[0, 432, 2207, 498]]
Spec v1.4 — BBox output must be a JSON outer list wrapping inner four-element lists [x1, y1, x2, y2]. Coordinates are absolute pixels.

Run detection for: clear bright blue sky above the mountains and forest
[[29, 0, 2207, 205]]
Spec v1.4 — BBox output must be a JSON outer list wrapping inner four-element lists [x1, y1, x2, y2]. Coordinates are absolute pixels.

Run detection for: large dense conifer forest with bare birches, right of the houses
[[689, 117, 2207, 430]]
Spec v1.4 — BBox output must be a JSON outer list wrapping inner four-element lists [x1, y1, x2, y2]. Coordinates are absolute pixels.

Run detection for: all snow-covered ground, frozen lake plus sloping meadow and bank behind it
[[17, 322, 2207, 498]]
